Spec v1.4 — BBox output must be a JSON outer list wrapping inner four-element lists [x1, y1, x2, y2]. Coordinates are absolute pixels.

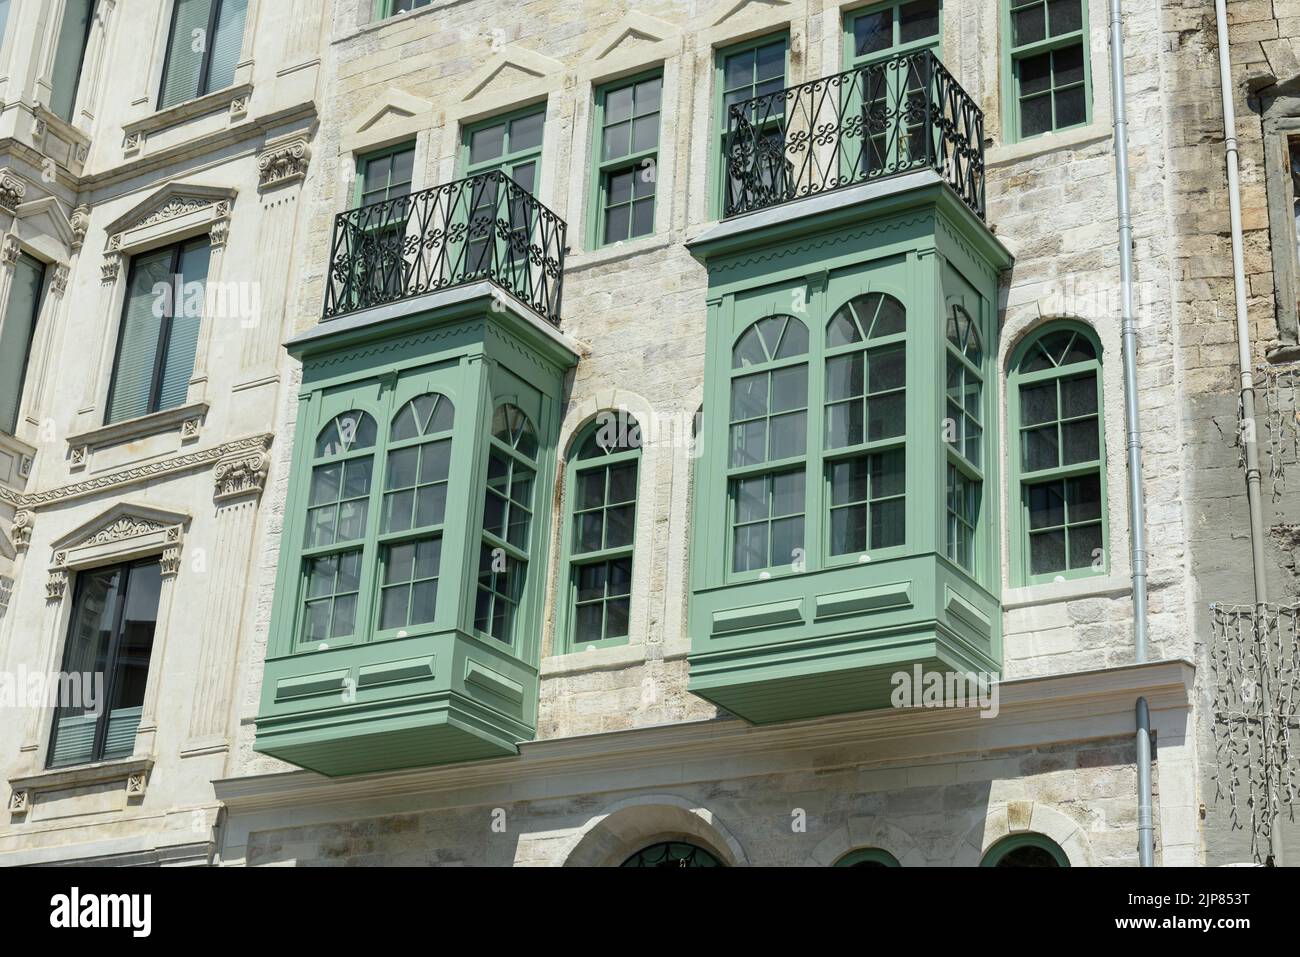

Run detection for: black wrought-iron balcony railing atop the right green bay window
[[724, 51, 984, 217]]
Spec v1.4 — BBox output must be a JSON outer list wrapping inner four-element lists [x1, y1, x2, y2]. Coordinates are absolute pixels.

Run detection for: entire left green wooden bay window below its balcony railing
[[256, 293, 576, 775]]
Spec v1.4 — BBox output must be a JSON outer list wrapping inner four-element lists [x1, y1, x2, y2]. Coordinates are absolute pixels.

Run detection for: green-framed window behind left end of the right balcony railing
[[709, 33, 790, 218]]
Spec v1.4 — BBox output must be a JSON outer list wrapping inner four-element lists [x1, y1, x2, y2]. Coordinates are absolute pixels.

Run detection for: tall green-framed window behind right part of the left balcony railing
[[462, 107, 546, 272]]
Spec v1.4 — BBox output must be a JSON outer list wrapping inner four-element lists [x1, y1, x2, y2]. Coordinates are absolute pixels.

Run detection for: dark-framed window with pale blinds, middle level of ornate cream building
[[105, 237, 211, 424]]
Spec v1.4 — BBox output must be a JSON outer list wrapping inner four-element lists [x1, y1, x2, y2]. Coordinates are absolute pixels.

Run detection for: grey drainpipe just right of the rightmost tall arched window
[[1110, 0, 1159, 867]]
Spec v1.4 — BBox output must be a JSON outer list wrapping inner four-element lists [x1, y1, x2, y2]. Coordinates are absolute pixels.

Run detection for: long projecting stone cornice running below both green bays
[[213, 659, 1195, 813]]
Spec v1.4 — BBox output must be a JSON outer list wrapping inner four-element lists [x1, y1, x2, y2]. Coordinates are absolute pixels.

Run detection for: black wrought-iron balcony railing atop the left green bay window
[[324, 170, 567, 325]]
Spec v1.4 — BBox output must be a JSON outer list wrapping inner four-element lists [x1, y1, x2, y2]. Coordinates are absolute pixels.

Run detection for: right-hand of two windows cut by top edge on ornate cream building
[[159, 0, 248, 109]]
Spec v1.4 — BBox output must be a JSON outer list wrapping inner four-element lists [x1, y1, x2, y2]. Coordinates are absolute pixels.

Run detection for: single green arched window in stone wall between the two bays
[[566, 412, 641, 648]]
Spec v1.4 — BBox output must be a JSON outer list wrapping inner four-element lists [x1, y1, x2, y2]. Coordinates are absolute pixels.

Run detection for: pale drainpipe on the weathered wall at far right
[[1214, 0, 1282, 867]]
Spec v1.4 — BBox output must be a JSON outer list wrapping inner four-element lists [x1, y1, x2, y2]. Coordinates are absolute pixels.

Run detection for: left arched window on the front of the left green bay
[[300, 411, 377, 641]]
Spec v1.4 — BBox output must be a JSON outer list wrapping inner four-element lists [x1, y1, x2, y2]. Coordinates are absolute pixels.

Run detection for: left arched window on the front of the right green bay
[[727, 315, 809, 572]]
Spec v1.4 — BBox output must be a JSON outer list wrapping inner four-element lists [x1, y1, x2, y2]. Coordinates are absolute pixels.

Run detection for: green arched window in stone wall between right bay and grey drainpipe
[[1008, 322, 1108, 585]]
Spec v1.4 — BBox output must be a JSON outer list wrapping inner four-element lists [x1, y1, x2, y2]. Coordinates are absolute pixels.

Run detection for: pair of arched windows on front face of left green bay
[[295, 392, 456, 645]]
